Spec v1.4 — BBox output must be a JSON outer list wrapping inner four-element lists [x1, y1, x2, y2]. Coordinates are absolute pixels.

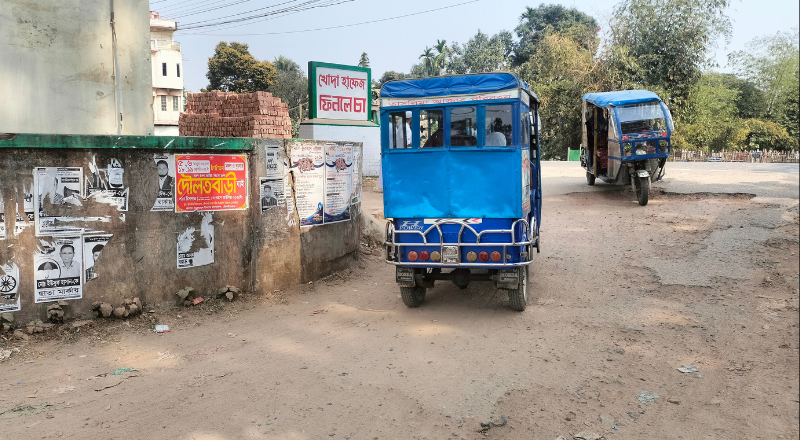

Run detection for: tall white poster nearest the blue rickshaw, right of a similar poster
[[323, 143, 353, 223]]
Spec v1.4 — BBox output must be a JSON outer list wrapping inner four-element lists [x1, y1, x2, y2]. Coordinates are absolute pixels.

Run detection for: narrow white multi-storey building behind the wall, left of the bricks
[[150, 11, 183, 136]]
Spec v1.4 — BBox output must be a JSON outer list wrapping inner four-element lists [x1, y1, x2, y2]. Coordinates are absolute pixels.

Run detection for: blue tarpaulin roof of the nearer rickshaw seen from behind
[[381, 72, 538, 101]]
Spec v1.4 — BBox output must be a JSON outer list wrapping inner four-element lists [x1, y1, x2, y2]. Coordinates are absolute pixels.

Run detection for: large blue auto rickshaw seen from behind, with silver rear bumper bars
[[380, 73, 542, 311]]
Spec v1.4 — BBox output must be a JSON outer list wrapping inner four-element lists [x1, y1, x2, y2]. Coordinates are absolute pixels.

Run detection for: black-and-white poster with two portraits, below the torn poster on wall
[[33, 236, 83, 303]]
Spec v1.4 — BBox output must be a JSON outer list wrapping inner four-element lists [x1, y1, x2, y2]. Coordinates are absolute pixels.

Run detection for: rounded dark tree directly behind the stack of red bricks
[[206, 41, 276, 93]]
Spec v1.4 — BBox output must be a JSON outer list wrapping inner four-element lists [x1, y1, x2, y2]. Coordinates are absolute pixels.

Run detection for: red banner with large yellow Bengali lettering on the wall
[[175, 154, 247, 212]]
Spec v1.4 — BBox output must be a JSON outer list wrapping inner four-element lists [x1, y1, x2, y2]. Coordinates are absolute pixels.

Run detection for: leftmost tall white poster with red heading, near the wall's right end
[[291, 142, 326, 226]]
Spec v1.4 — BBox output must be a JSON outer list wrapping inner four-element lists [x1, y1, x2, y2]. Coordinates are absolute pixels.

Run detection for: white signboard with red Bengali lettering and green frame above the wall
[[308, 61, 372, 121]]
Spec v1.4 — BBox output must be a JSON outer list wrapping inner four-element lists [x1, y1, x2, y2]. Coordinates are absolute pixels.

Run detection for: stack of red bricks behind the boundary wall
[[178, 91, 292, 139]]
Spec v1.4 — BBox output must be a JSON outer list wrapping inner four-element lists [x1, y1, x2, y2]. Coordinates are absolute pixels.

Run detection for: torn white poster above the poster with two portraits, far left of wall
[[33, 167, 89, 237]]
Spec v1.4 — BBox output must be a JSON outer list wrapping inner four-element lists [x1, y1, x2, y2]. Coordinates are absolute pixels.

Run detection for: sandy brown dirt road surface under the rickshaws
[[0, 163, 800, 440]]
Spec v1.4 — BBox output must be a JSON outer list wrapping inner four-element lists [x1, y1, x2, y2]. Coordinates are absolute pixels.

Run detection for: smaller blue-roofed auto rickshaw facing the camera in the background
[[581, 90, 674, 206]]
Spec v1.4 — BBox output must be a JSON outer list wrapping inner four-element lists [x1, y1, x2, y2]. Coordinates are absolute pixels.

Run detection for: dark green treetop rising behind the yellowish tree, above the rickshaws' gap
[[512, 3, 600, 66]]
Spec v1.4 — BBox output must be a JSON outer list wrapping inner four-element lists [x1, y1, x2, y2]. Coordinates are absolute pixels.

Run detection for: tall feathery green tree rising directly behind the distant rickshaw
[[610, 0, 731, 115]]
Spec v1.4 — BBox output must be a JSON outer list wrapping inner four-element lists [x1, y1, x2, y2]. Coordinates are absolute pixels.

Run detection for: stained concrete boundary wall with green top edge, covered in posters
[[0, 134, 362, 325]]
